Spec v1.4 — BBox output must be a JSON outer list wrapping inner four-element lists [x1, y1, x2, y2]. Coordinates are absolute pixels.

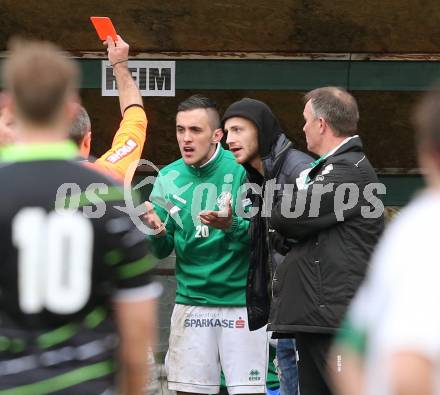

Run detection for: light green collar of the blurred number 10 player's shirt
[[0, 140, 78, 162]]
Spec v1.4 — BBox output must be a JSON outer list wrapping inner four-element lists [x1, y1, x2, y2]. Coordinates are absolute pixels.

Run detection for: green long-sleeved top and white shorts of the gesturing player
[[150, 144, 268, 394]]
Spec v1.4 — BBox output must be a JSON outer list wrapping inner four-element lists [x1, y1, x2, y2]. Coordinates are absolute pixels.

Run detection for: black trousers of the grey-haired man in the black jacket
[[295, 333, 333, 395]]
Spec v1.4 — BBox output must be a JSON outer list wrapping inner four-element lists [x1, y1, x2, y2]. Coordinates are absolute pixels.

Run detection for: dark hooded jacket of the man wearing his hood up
[[223, 98, 313, 330]]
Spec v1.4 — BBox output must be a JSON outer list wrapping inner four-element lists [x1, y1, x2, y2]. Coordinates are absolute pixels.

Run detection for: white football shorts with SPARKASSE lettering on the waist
[[165, 304, 269, 395]]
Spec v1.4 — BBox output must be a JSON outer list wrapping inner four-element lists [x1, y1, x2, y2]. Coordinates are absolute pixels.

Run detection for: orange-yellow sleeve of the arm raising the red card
[[95, 106, 148, 182]]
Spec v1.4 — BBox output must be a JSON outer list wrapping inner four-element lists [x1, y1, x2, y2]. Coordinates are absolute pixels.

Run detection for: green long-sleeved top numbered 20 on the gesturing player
[[149, 144, 249, 306]]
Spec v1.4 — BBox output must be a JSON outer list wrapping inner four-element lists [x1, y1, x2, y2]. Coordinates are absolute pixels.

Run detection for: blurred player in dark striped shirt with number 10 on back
[[0, 38, 159, 395]]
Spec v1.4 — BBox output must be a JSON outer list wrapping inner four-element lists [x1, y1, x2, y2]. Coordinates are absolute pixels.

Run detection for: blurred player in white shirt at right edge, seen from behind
[[333, 89, 440, 395]]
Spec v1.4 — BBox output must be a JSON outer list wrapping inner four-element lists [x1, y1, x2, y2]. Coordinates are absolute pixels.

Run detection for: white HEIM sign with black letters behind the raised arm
[[101, 60, 176, 96]]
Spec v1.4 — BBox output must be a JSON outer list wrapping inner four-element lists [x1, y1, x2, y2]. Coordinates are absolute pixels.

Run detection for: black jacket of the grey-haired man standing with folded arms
[[269, 136, 385, 334]]
